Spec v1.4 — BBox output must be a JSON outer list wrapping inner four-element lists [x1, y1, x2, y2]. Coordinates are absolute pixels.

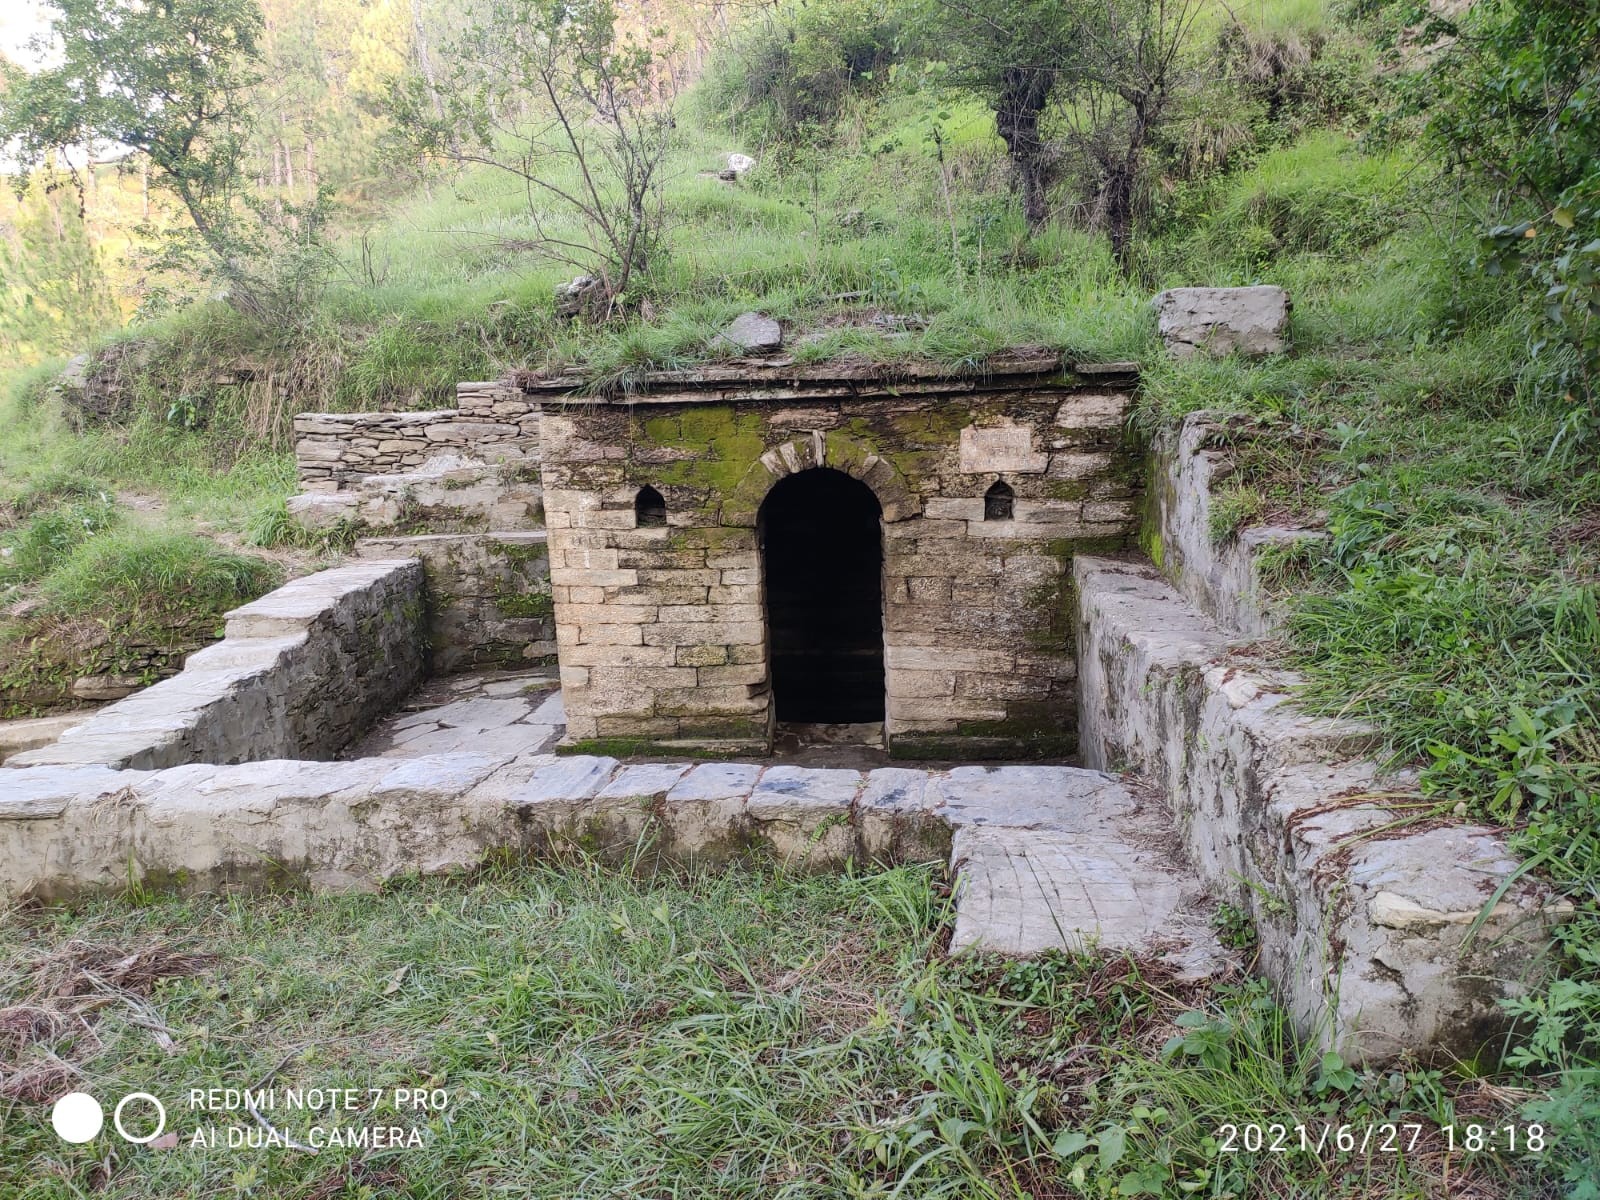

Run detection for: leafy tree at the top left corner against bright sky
[[0, 0, 323, 318]]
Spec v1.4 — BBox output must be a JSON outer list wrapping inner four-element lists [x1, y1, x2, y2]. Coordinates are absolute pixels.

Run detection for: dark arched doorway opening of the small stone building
[[757, 467, 885, 725]]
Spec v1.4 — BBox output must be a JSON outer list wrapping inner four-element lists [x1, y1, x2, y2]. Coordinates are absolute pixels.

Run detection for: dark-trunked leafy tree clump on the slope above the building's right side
[[926, 0, 1200, 269]]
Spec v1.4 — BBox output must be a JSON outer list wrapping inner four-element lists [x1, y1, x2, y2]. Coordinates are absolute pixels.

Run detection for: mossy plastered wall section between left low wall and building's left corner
[[355, 530, 555, 674]]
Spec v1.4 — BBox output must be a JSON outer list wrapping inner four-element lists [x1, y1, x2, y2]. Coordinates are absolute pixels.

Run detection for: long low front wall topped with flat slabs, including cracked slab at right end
[[0, 754, 1227, 974]]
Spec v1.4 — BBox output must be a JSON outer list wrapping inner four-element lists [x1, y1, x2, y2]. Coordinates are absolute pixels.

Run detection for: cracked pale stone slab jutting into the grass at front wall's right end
[[950, 826, 1227, 979]]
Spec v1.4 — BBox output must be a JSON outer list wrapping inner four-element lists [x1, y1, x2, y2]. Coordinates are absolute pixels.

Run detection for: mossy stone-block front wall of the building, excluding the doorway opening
[[541, 374, 1142, 758]]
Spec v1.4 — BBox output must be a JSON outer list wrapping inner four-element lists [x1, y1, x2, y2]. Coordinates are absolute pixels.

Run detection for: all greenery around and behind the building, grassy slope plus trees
[[0, 0, 1600, 1197]]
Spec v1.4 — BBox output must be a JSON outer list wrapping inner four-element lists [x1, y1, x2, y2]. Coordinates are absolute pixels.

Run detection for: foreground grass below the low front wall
[[0, 861, 1507, 1200]]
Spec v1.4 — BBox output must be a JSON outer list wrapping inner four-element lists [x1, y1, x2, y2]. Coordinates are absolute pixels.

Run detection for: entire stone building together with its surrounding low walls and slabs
[[0, 302, 1542, 1062]]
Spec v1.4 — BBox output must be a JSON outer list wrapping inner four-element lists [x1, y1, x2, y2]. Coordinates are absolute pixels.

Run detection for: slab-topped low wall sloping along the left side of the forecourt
[[0, 558, 426, 771]]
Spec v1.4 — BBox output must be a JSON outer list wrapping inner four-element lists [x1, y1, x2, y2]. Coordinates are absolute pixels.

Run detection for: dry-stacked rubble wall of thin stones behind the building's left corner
[[294, 382, 539, 493]]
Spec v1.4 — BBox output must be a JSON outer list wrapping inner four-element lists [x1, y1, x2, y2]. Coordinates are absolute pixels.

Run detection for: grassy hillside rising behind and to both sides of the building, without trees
[[0, 0, 1600, 1197]]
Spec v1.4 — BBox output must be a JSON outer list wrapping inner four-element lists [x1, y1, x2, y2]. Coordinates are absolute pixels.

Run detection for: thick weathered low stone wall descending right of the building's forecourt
[[1074, 558, 1566, 1061]]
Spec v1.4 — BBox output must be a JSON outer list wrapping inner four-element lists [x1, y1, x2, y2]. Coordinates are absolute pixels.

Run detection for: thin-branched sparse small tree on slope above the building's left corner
[[390, 0, 674, 314]]
